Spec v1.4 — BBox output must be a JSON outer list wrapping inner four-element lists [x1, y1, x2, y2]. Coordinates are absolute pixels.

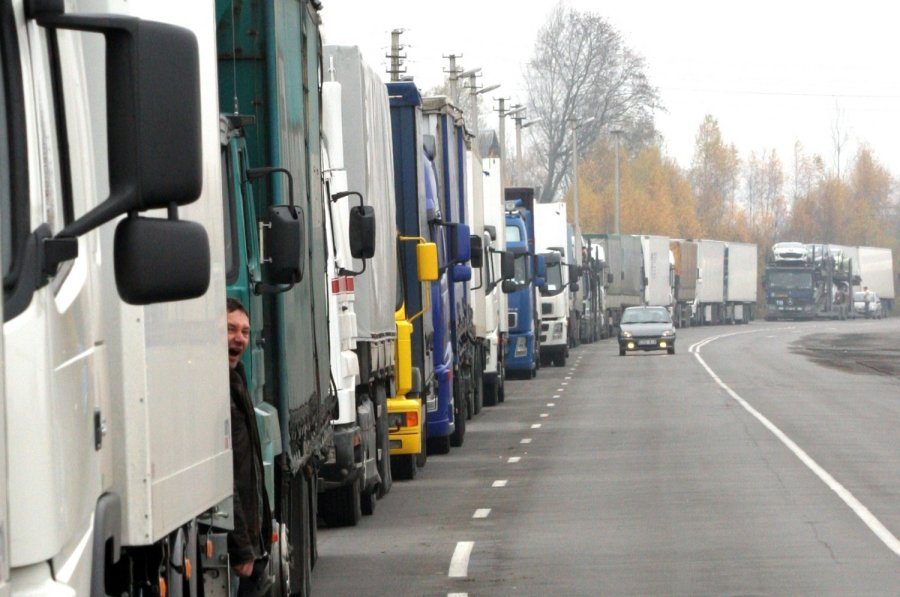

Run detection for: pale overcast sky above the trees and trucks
[[321, 0, 900, 176]]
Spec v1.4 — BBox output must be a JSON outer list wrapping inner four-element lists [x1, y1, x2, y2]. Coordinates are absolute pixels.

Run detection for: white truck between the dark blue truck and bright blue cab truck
[[466, 130, 508, 406]]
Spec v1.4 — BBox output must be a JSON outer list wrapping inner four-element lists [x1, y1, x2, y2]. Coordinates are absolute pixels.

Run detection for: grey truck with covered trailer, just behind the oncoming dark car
[[586, 234, 645, 336]]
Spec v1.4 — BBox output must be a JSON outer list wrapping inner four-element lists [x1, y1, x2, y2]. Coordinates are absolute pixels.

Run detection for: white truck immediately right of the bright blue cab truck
[[534, 201, 571, 367]]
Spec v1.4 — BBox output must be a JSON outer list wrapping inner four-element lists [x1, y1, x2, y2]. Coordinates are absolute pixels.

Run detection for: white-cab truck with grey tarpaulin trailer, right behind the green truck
[[320, 46, 402, 518]]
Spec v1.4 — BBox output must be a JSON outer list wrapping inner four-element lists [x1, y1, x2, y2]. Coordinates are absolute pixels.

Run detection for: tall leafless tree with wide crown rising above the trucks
[[526, 4, 659, 201]]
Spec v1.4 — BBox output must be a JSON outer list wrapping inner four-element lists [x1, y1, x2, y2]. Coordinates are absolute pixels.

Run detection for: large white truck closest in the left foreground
[[0, 0, 233, 595]]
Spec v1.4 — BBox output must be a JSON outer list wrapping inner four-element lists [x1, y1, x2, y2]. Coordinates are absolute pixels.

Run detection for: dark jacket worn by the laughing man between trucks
[[228, 363, 272, 565]]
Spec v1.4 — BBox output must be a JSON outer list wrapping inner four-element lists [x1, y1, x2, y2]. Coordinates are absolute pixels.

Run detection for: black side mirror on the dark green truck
[[261, 205, 306, 284]]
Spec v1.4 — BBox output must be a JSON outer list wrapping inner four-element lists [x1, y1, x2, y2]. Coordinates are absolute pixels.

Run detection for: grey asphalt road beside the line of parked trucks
[[313, 318, 900, 595]]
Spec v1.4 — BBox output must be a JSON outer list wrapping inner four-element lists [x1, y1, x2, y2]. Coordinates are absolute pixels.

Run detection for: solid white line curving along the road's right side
[[688, 328, 900, 556]]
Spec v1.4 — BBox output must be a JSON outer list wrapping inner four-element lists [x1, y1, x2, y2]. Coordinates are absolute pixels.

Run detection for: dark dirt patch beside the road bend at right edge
[[791, 333, 900, 377]]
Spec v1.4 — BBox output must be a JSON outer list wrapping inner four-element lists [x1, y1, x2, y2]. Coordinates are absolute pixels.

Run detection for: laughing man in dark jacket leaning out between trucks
[[228, 299, 272, 595]]
